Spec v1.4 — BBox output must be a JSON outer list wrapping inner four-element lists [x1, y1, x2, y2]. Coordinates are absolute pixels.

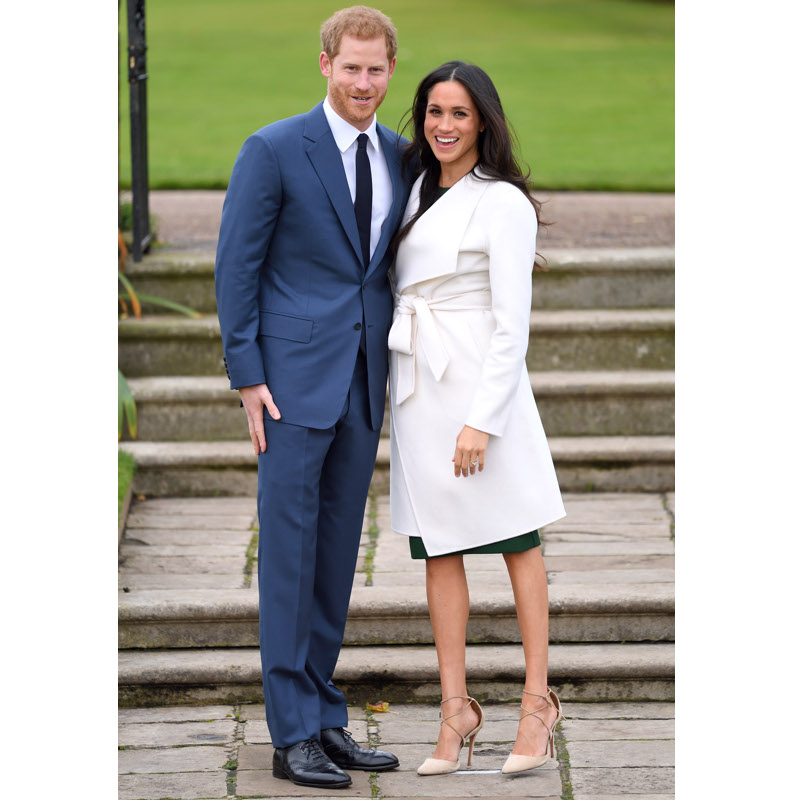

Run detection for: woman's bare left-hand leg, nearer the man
[[425, 556, 478, 761]]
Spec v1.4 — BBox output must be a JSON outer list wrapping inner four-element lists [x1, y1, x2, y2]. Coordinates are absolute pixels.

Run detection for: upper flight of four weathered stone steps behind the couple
[[119, 248, 675, 496]]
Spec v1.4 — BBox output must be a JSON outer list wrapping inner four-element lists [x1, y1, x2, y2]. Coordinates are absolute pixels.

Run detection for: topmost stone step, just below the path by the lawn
[[125, 247, 675, 314]]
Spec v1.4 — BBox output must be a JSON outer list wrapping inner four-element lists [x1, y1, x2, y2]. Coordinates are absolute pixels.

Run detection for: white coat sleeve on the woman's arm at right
[[466, 183, 538, 436]]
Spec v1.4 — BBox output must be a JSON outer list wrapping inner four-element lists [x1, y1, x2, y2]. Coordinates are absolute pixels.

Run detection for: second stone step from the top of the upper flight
[[119, 309, 675, 378]]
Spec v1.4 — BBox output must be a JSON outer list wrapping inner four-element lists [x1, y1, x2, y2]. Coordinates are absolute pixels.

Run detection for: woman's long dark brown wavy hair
[[392, 61, 547, 267]]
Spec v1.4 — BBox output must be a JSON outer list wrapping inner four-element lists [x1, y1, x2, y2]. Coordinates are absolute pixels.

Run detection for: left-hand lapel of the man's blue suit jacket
[[303, 103, 361, 263]]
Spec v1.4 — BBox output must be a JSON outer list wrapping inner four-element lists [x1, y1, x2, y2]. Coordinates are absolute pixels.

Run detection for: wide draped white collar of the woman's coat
[[395, 170, 490, 292]]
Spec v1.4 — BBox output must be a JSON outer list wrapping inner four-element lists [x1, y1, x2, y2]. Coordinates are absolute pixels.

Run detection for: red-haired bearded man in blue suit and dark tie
[[215, 6, 409, 788]]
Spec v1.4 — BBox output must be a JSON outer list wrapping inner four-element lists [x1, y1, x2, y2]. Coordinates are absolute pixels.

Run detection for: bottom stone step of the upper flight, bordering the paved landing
[[120, 436, 675, 497]]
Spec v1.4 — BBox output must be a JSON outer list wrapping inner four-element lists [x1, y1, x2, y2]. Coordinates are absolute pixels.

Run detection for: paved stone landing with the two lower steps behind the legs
[[118, 493, 674, 705]]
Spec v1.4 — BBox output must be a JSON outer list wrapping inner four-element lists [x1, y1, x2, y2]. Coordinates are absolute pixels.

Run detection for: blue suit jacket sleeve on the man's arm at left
[[214, 133, 282, 389]]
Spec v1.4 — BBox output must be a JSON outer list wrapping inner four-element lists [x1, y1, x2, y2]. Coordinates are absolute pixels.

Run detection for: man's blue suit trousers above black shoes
[[258, 352, 380, 747]]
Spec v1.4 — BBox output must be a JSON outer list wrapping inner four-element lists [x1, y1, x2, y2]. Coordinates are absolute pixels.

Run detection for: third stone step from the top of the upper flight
[[126, 370, 675, 441]]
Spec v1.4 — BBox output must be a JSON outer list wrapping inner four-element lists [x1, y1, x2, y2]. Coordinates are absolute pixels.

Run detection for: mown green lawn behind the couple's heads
[[120, 0, 674, 191]]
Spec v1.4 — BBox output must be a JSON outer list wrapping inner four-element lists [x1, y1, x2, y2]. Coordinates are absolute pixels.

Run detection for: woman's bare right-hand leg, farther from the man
[[503, 547, 556, 756]]
